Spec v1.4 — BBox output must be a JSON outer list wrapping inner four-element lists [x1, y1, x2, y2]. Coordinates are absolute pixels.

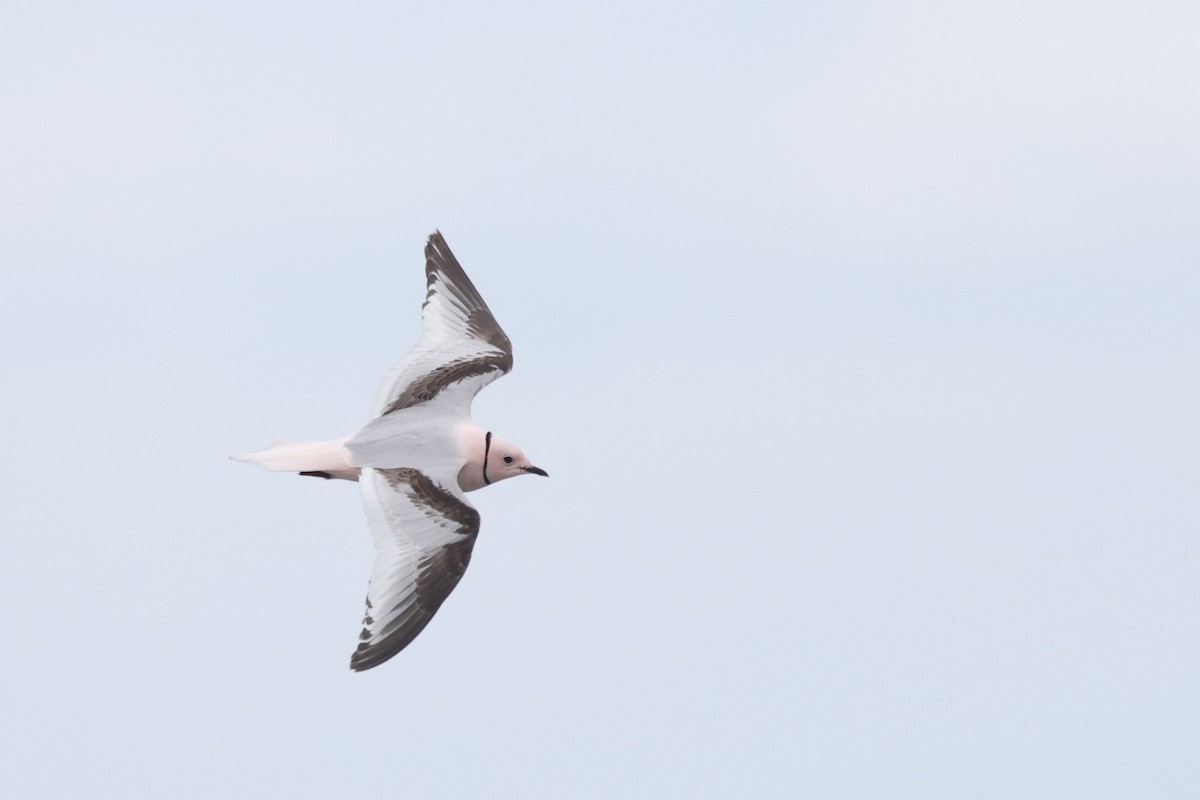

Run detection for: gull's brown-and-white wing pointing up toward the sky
[[373, 231, 512, 417]]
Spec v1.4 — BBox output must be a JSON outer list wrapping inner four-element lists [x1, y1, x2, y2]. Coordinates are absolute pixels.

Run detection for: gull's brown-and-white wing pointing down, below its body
[[350, 468, 479, 672]]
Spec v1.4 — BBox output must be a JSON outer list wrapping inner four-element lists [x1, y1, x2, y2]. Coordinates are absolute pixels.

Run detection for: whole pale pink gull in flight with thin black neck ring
[[234, 231, 546, 670]]
